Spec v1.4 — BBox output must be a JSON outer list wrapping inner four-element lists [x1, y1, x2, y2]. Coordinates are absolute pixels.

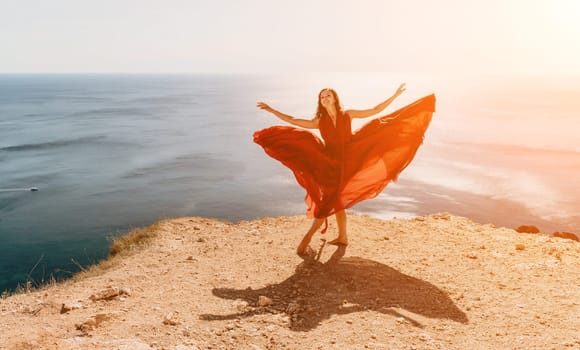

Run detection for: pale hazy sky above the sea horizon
[[0, 0, 580, 76]]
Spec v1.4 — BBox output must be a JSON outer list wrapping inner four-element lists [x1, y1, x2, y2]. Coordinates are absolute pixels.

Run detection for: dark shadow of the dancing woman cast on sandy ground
[[201, 247, 468, 331]]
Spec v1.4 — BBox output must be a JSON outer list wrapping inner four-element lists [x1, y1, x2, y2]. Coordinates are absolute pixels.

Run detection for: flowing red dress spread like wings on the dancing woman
[[254, 95, 435, 218]]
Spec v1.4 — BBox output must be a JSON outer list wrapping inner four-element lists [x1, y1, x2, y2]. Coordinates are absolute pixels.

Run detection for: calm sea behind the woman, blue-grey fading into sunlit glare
[[0, 73, 580, 293]]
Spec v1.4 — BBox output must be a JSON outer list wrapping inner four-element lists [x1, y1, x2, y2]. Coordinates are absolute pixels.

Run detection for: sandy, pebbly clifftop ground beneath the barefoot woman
[[0, 214, 580, 350]]
